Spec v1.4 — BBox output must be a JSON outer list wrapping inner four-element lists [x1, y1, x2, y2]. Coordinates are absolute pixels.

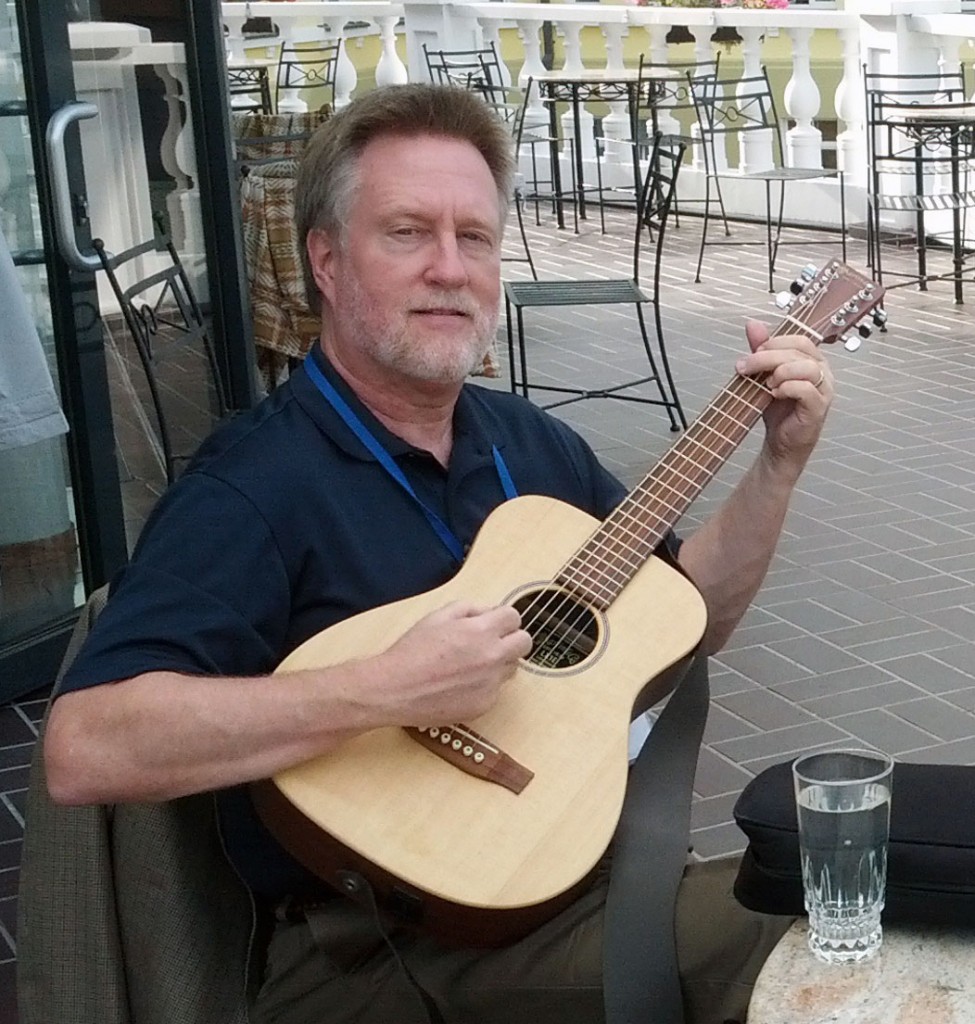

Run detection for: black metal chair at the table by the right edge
[[863, 70, 975, 302]]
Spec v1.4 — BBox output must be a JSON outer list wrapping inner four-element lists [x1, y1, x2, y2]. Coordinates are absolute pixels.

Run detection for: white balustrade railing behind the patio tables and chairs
[[102, 0, 975, 272]]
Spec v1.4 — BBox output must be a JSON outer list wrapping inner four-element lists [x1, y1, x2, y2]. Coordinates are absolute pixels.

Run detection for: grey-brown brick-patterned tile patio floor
[[0, 203, 975, 1024]]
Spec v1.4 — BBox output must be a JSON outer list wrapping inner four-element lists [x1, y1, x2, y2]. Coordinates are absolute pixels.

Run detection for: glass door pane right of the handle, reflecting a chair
[[69, 2, 225, 550]]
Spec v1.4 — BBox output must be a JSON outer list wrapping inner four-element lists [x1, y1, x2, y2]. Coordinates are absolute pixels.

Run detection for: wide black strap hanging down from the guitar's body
[[603, 651, 710, 1024]]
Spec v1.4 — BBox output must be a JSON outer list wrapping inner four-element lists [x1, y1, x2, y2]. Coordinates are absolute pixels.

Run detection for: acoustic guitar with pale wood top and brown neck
[[252, 261, 883, 945]]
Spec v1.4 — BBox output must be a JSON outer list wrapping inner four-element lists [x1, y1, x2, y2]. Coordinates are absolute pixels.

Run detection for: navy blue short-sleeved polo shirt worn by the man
[[62, 349, 671, 897]]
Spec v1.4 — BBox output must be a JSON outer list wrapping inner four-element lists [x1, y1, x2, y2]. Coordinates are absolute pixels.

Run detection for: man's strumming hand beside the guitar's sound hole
[[376, 601, 532, 725]]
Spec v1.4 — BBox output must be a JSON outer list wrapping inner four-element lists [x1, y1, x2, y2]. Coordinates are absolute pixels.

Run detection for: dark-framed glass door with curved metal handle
[[0, 0, 254, 701]]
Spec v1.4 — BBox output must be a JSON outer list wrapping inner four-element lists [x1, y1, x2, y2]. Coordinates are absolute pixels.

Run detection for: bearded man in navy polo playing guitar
[[45, 85, 832, 1024]]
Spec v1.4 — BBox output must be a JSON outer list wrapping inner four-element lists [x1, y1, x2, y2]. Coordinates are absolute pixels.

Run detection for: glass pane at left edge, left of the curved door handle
[[0, 4, 83, 647]]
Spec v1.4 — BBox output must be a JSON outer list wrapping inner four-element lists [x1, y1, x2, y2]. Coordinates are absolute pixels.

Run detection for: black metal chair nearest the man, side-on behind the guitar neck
[[505, 135, 687, 430]]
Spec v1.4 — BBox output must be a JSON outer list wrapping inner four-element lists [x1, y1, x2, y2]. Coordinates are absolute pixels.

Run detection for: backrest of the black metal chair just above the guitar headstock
[[688, 68, 782, 174]]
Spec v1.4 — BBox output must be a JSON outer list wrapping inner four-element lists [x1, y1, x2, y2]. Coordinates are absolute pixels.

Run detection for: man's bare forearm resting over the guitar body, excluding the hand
[[44, 663, 385, 804]]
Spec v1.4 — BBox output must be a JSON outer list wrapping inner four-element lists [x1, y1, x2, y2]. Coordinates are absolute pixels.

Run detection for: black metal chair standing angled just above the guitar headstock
[[690, 68, 846, 292]]
